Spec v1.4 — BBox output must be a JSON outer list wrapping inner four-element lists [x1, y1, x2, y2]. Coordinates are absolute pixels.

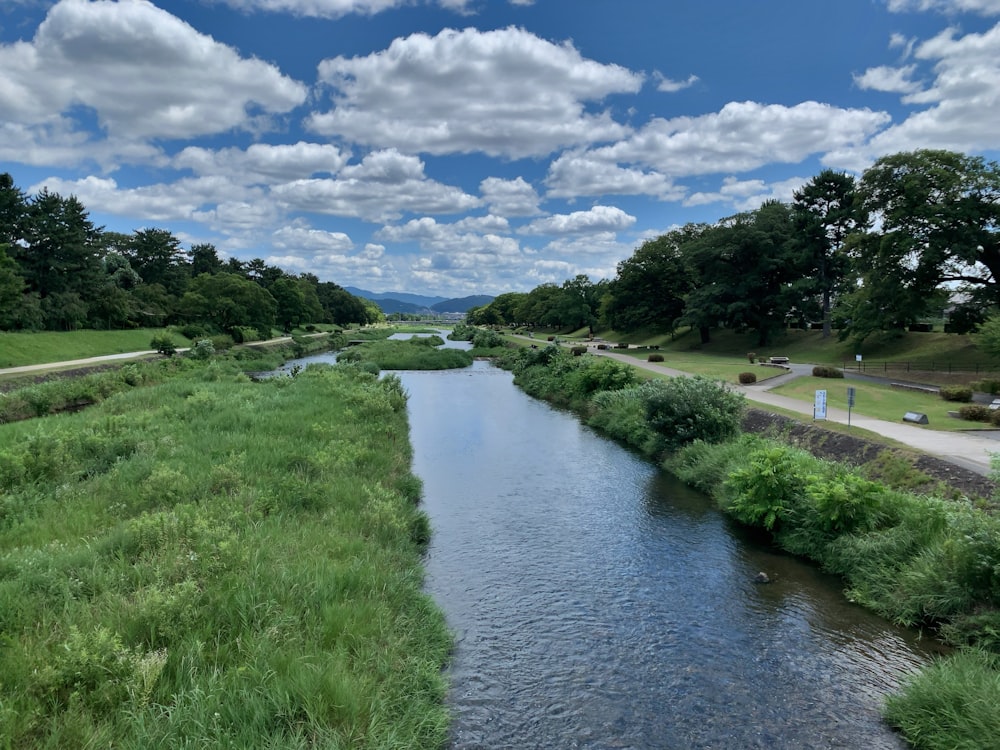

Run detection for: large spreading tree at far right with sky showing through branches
[[842, 150, 1000, 340]]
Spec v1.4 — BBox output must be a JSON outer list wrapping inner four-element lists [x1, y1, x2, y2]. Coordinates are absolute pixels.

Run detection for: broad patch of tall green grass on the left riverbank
[[0, 361, 451, 748]]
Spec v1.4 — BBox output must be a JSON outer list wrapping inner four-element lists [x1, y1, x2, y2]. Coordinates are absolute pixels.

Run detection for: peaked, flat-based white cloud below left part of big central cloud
[[271, 149, 482, 222]]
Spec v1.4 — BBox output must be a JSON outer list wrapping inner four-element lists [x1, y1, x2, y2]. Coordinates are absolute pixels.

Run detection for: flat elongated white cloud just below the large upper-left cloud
[[172, 141, 350, 185]]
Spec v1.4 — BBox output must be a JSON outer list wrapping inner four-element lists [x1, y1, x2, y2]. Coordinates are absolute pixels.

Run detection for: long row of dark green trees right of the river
[[468, 150, 1000, 345]]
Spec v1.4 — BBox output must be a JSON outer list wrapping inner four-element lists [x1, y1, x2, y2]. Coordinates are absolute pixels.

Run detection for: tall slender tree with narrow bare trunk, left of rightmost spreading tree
[[792, 169, 867, 338]]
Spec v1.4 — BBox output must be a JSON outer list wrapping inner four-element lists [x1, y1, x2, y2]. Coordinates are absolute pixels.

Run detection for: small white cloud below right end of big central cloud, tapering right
[[545, 151, 684, 199]]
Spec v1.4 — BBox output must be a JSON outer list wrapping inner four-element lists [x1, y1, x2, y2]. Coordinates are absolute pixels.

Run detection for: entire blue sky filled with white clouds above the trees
[[0, 0, 1000, 297]]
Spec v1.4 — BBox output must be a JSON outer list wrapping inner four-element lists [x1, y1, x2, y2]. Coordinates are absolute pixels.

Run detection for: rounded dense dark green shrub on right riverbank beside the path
[[646, 375, 746, 450]]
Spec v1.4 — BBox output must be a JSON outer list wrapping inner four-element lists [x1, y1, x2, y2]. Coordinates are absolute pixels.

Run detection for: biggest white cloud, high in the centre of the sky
[[308, 28, 642, 158]]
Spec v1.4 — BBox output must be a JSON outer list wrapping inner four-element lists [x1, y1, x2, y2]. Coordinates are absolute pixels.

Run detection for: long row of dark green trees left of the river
[[0, 173, 382, 336]]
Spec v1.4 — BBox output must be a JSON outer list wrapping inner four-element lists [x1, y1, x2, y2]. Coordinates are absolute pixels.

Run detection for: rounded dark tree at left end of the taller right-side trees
[[602, 224, 706, 332]]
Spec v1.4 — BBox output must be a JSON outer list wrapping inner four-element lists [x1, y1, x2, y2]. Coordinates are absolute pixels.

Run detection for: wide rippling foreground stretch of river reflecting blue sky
[[401, 363, 931, 748]]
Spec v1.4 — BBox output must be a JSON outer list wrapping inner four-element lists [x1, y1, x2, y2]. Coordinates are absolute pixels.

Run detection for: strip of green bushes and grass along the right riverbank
[[500, 346, 1000, 750]]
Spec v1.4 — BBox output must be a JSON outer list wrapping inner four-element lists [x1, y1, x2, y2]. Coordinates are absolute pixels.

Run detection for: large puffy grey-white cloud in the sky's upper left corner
[[0, 0, 308, 139]]
